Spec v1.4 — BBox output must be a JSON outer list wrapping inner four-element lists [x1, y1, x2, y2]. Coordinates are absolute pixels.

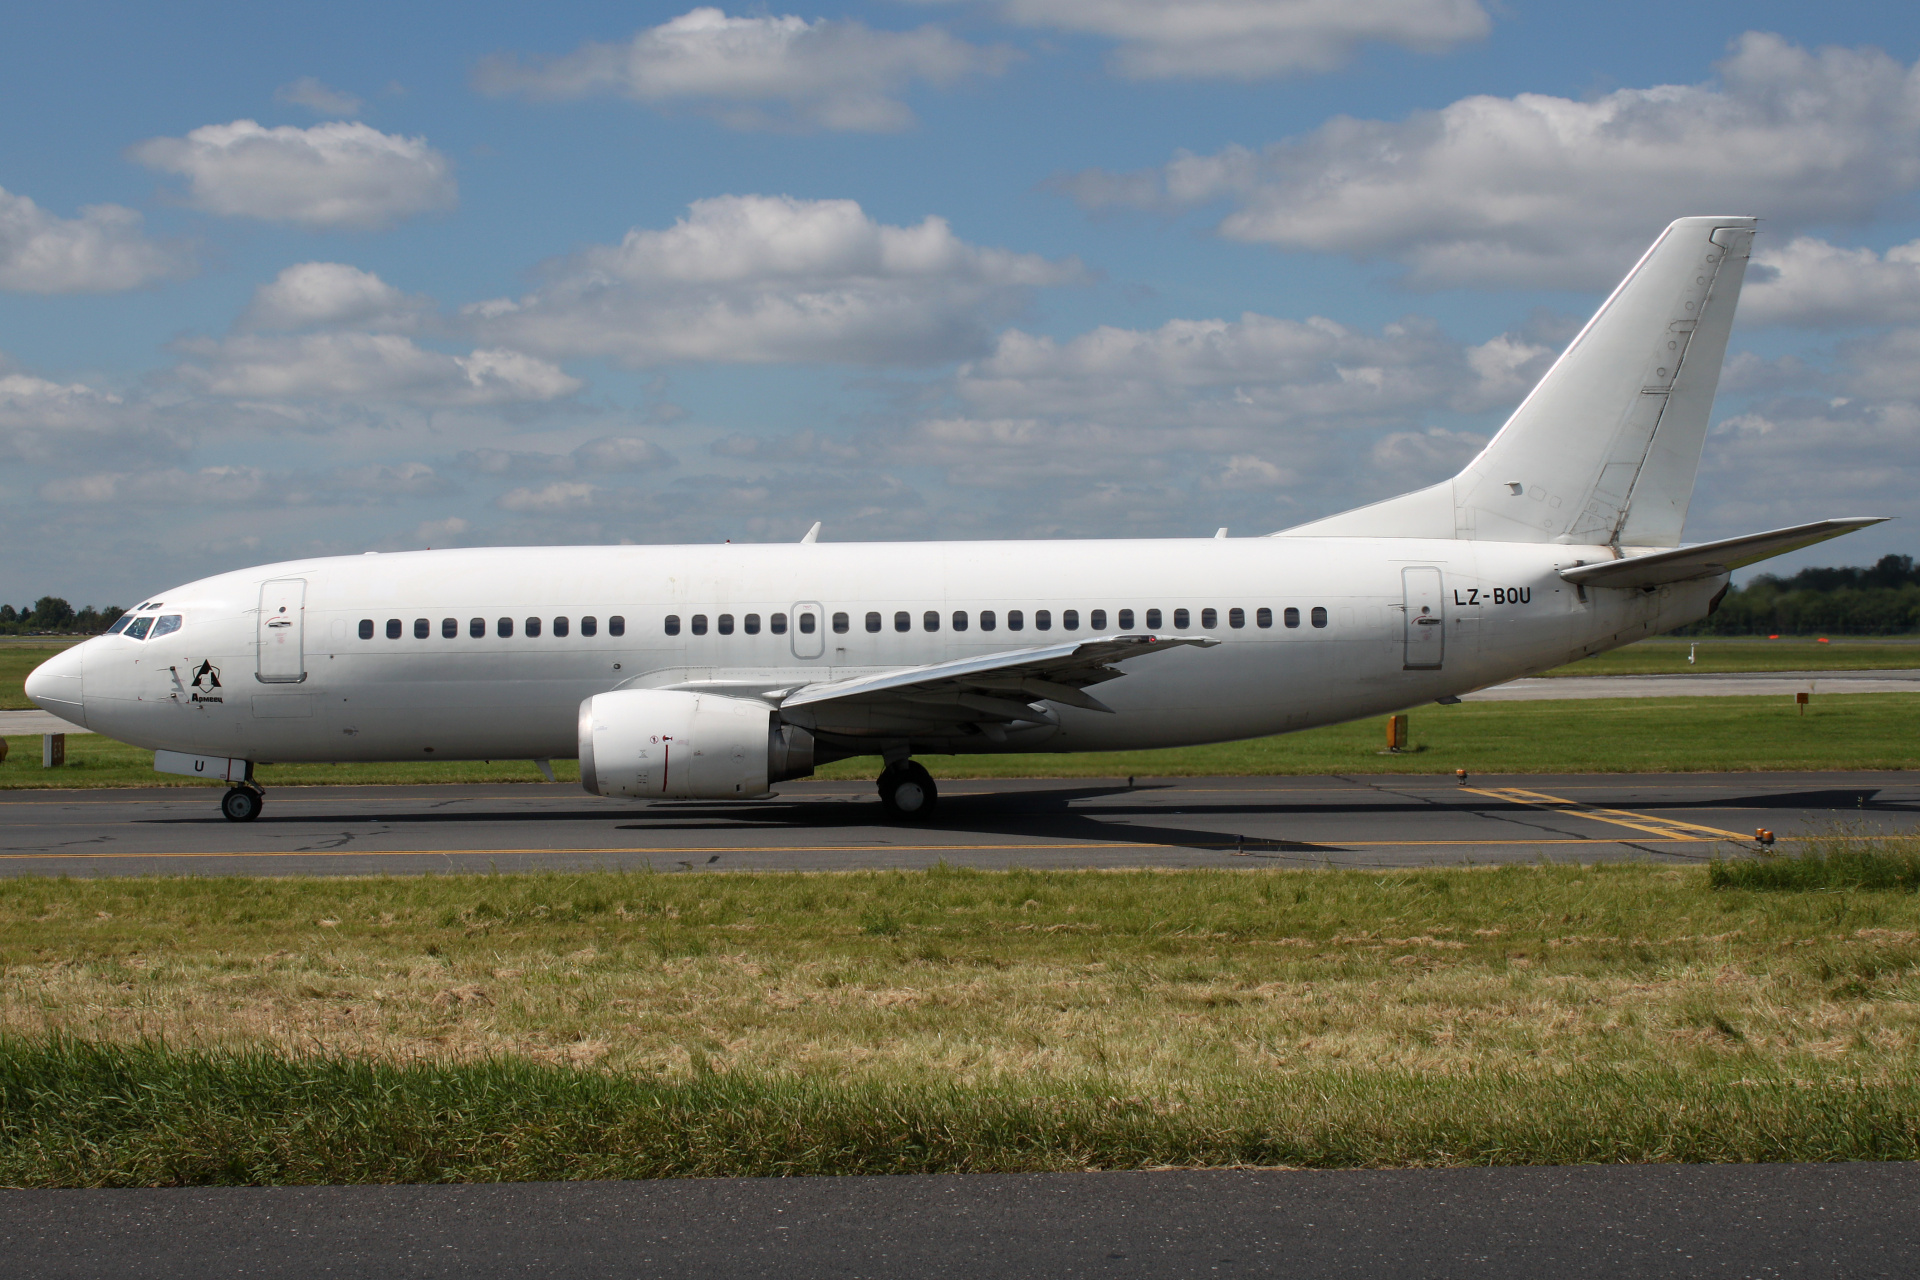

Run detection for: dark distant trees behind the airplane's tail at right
[[1680, 555, 1920, 635]]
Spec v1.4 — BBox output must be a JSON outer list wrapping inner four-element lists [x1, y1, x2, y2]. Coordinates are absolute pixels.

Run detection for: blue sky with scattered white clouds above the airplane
[[0, 0, 1920, 604]]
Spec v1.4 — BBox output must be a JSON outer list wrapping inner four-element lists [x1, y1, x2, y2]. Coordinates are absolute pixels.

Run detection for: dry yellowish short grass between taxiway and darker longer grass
[[0, 867, 1920, 1096]]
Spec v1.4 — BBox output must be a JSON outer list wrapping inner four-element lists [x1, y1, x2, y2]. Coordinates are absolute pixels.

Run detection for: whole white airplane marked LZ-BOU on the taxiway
[[27, 217, 1878, 821]]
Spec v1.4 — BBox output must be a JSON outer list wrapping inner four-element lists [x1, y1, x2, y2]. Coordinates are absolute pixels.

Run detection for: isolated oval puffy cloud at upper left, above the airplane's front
[[131, 121, 457, 230]]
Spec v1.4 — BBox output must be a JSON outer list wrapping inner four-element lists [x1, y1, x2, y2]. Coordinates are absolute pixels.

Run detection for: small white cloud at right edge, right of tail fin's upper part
[[1740, 236, 1920, 326]]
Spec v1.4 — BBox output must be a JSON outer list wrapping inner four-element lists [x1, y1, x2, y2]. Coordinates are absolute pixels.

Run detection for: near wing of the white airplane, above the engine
[[780, 635, 1219, 737]]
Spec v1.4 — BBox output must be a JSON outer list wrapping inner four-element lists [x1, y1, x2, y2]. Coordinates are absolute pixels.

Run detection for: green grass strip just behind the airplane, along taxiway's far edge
[[0, 693, 1920, 787]]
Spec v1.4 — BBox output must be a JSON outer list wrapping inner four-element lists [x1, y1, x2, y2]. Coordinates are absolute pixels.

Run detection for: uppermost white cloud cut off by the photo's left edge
[[0, 188, 192, 294]]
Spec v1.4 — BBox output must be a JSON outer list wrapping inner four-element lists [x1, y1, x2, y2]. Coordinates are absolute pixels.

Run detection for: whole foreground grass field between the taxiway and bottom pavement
[[0, 846, 1920, 1186]]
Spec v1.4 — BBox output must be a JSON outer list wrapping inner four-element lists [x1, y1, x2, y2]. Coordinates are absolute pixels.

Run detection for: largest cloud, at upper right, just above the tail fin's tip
[[1058, 33, 1920, 288]]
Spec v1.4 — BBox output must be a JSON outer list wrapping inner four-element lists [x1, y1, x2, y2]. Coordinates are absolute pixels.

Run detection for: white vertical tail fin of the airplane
[[1284, 217, 1757, 547]]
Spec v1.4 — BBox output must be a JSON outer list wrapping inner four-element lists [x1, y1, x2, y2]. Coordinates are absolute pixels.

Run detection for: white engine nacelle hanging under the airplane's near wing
[[580, 689, 814, 800]]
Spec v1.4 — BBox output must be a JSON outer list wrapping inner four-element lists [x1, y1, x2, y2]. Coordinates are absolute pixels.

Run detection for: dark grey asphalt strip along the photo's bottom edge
[[0, 1163, 1920, 1280]]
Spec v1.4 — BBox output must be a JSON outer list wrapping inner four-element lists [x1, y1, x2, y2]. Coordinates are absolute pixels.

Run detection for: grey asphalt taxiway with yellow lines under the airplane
[[0, 771, 1920, 875]]
